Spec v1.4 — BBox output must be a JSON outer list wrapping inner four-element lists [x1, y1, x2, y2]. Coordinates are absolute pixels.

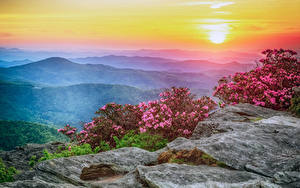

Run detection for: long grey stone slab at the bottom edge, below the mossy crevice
[[137, 164, 279, 188]]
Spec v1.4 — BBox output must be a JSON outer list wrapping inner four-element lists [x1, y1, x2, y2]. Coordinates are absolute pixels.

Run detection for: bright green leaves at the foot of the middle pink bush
[[114, 131, 168, 151]]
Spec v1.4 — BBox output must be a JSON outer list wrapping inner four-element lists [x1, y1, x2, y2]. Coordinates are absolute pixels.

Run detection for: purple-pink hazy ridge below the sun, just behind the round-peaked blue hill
[[71, 55, 254, 74]]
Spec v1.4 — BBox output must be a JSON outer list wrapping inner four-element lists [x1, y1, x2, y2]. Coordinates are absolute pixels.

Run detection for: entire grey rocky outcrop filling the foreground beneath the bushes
[[1, 104, 300, 188]]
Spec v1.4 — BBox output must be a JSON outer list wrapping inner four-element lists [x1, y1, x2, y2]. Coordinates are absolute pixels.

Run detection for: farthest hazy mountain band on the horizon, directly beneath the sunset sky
[[0, 47, 261, 64]]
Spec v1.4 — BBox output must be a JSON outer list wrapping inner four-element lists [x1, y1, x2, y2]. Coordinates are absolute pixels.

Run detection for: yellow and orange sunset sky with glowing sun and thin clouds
[[0, 0, 300, 50]]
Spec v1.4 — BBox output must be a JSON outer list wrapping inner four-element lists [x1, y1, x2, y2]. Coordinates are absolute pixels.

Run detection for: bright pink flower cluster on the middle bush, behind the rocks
[[138, 87, 216, 140]]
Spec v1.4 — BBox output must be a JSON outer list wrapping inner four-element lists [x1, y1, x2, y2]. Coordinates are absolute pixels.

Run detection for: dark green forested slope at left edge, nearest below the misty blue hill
[[0, 121, 67, 150]]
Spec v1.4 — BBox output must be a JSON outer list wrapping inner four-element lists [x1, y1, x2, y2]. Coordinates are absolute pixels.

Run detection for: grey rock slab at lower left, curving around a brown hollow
[[36, 147, 158, 186]]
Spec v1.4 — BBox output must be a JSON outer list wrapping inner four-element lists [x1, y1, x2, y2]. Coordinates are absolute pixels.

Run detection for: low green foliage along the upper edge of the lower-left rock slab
[[38, 144, 99, 162]]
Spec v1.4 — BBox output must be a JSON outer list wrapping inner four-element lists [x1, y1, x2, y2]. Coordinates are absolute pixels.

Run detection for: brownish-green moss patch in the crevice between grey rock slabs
[[157, 148, 231, 169]]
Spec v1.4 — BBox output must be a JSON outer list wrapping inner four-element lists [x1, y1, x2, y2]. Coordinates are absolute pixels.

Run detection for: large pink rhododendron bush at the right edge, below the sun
[[214, 49, 300, 110]]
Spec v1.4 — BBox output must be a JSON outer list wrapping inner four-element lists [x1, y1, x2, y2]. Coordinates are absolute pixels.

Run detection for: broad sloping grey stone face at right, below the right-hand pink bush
[[168, 122, 300, 177]]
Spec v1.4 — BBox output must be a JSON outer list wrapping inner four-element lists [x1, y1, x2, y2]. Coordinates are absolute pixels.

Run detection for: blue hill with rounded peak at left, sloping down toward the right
[[0, 57, 216, 89]]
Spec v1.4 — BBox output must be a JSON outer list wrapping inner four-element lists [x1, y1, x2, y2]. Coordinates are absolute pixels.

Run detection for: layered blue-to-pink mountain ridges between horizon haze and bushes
[[0, 55, 253, 148]]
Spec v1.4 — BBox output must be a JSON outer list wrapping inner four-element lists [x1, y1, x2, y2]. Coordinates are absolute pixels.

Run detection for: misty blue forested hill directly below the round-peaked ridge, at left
[[0, 81, 159, 127]]
